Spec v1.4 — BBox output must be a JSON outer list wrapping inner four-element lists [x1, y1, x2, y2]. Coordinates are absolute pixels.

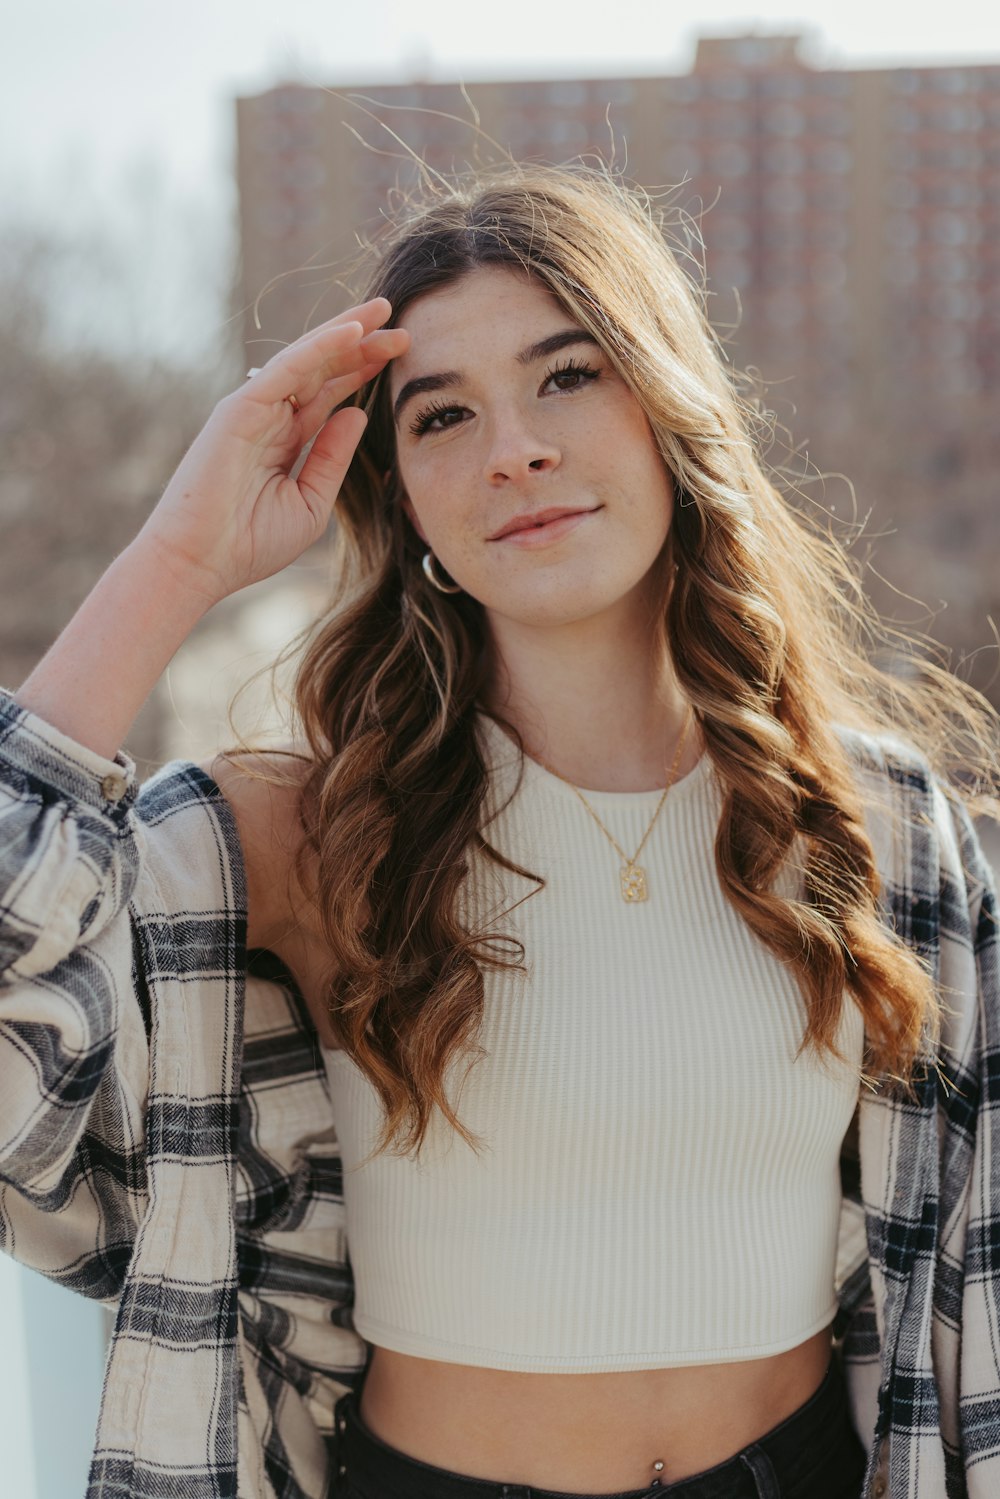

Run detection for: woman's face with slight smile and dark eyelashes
[[390, 267, 673, 633]]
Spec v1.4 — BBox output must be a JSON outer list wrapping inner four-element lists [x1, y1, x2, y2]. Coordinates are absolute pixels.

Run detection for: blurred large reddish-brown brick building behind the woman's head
[[237, 34, 1000, 695]]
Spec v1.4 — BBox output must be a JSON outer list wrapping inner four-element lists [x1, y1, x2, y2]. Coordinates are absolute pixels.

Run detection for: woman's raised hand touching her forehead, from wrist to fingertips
[[133, 297, 409, 606]]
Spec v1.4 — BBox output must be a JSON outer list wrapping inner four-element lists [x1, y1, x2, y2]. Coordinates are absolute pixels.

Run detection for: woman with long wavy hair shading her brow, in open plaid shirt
[[0, 168, 1000, 1499]]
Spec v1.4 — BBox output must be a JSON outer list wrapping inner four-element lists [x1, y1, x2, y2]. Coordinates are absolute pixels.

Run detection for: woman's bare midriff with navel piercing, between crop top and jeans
[[360, 1328, 832, 1495]]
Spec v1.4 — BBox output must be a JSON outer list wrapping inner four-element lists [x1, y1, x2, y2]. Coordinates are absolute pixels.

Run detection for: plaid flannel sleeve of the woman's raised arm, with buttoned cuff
[[0, 693, 148, 1300]]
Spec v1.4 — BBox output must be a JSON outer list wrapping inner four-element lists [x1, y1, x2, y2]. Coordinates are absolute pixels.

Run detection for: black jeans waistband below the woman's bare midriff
[[331, 1358, 867, 1499]]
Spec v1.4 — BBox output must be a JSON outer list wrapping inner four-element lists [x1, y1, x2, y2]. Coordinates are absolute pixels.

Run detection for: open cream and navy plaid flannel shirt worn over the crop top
[[0, 694, 1000, 1499]]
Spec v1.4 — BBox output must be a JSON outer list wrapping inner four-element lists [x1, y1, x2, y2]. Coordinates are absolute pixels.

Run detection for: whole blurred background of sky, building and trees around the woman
[[0, 0, 1000, 1499]]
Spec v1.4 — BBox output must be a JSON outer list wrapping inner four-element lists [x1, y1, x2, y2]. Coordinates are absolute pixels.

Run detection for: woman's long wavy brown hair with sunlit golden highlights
[[262, 155, 996, 1153]]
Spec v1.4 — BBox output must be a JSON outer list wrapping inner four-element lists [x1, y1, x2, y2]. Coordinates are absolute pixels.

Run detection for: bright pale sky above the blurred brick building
[[0, 0, 1000, 356]]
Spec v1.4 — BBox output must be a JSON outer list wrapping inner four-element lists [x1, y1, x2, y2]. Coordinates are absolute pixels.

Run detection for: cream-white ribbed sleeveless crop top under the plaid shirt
[[325, 718, 862, 1373]]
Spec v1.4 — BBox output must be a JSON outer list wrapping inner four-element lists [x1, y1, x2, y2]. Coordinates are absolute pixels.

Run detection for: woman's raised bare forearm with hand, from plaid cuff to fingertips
[[15, 310, 408, 758]]
